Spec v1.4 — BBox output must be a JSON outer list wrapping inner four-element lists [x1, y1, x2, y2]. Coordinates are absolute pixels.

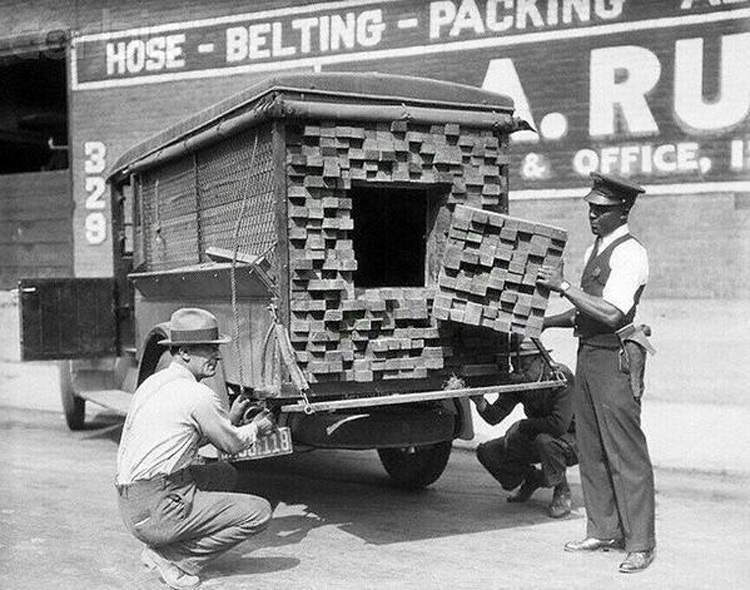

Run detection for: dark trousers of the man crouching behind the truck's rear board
[[477, 427, 578, 490]]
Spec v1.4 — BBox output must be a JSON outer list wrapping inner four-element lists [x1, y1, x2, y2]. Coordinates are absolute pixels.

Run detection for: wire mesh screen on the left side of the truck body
[[139, 125, 276, 271]]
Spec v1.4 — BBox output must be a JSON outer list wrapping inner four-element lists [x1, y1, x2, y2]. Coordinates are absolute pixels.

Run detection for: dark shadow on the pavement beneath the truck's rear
[[238, 451, 581, 547]]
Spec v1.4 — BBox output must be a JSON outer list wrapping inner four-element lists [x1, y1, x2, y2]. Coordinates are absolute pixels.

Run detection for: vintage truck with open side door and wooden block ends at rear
[[19, 73, 564, 488]]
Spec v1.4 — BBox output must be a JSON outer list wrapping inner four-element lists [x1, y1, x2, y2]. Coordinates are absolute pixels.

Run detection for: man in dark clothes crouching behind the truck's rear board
[[471, 339, 578, 518]]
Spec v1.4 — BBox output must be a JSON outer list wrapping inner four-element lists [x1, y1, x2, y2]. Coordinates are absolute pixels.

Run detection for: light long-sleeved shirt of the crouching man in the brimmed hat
[[116, 362, 257, 484]]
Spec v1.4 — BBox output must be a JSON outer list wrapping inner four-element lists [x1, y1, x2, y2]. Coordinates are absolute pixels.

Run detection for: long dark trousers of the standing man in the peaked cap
[[573, 345, 656, 551]]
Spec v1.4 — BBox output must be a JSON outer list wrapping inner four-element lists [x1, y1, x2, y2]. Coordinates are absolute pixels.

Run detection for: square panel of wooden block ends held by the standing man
[[433, 205, 567, 337]]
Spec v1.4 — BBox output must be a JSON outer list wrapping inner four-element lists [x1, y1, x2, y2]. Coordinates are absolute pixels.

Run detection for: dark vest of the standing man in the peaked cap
[[575, 234, 645, 348]]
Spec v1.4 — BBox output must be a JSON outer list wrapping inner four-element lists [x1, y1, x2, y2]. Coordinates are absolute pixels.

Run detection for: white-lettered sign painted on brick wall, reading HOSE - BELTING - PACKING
[[71, 0, 750, 272]]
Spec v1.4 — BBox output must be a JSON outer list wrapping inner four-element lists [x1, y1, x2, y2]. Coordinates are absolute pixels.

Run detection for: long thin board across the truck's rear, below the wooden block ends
[[281, 380, 566, 414]]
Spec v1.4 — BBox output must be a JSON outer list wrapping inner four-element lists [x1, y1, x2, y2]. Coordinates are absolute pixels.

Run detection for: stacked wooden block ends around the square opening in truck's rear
[[287, 121, 508, 383]]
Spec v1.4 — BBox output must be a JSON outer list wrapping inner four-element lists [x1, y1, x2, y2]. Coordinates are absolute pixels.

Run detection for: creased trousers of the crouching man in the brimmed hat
[[117, 463, 271, 574]]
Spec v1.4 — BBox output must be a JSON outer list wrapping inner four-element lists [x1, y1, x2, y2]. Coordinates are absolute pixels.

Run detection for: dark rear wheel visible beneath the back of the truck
[[378, 441, 453, 490]]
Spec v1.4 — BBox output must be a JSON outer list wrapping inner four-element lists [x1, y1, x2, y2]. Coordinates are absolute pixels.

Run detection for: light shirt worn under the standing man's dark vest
[[583, 223, 649, 314]]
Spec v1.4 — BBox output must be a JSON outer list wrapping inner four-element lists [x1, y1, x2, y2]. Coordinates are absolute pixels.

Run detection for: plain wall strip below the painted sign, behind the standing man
[[510, 194, 750, 299]]
